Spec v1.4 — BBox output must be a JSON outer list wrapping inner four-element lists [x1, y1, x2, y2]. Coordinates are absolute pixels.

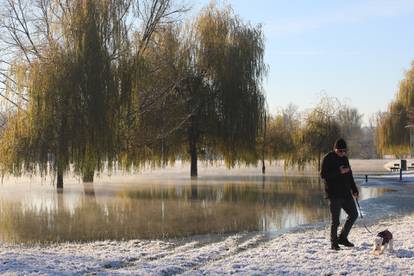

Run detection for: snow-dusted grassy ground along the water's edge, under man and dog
[[0, 176, 414, 275]]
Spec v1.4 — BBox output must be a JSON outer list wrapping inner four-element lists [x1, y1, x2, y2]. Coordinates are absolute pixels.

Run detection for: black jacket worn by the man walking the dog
[[321, 151, 358, 199]]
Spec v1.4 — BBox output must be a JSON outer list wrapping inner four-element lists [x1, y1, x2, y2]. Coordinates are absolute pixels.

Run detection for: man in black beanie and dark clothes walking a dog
[[321, 138, 359, 250]]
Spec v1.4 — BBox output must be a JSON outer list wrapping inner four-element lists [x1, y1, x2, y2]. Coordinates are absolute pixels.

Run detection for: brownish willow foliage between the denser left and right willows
[[115, 25, 189, 169]]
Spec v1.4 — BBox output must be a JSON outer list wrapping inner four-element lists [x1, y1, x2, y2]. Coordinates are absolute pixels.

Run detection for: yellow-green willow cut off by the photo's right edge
[[375, 63, 414, 156]]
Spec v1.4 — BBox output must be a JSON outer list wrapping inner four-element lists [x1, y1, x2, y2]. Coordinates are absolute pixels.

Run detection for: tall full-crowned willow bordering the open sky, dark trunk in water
[[154, 5, 266, 176]]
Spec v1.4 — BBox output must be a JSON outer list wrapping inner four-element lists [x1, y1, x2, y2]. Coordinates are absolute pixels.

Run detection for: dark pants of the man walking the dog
[[329, 197, 358, 243]]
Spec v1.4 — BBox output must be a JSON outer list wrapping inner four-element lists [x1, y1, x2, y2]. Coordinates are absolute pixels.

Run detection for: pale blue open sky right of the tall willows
[[189, 0, 414, 125]]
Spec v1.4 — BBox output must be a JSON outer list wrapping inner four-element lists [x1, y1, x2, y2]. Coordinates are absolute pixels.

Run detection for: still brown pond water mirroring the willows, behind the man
[[0, 178, 385, 242]]
